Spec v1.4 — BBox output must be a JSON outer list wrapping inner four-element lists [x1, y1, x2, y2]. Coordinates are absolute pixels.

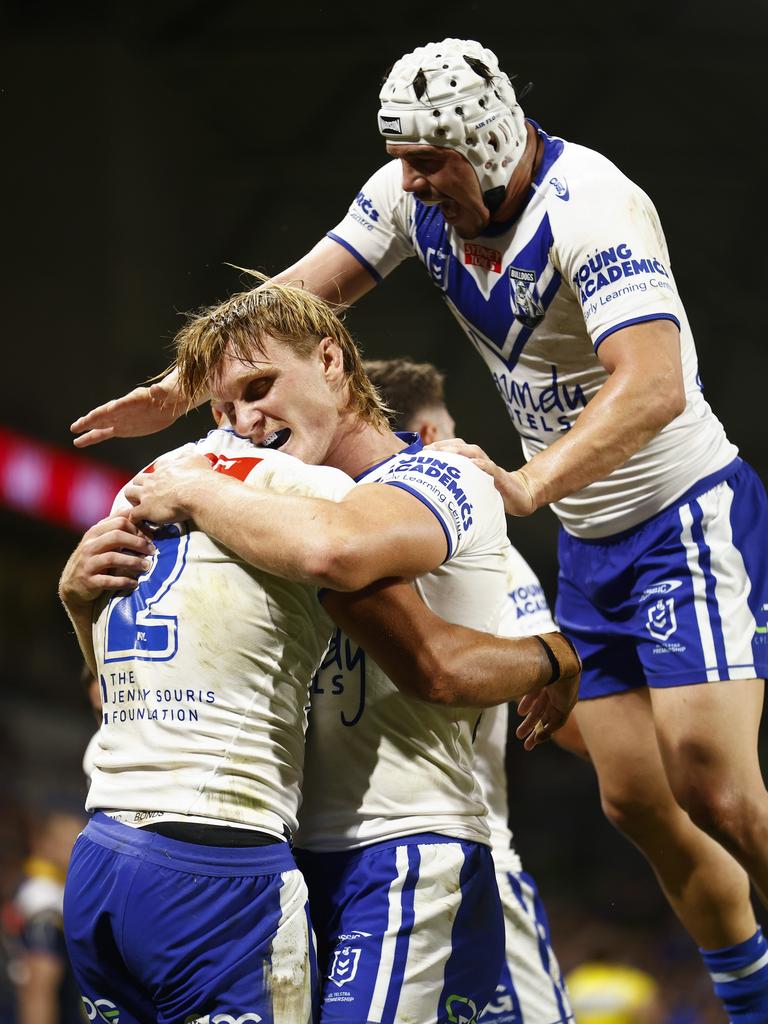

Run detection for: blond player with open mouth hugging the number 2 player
[[120, 286, 575, 1024]]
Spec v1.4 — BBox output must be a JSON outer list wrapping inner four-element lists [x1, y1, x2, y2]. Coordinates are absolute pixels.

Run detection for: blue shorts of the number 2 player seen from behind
[[65, 814, 316, 1024]]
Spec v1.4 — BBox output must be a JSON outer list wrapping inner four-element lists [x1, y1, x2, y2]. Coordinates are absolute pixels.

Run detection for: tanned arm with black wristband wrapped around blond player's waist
[[324, 580, 581, 749]]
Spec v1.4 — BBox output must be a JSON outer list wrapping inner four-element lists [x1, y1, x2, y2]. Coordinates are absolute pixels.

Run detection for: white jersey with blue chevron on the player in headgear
[[329, 126, 736, 538]]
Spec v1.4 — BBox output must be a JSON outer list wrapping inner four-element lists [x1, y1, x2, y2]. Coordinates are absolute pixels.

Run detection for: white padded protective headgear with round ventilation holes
[[379, 39, 527, 213]]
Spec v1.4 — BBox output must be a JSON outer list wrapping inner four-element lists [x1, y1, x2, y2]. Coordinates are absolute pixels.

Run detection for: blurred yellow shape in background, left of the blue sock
[[565, 963, 659, 1024]]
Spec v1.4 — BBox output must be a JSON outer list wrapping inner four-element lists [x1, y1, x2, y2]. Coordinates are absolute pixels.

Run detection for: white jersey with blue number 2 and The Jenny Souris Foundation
[[86, 430, 353, 837]]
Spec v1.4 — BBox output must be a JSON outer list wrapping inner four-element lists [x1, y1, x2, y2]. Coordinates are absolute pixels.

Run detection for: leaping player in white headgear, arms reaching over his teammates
[[73, 39, 768, 1022]]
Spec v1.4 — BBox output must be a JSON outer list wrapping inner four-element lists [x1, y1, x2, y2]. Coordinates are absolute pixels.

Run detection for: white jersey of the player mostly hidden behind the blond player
[[475, 545, 557, 871]]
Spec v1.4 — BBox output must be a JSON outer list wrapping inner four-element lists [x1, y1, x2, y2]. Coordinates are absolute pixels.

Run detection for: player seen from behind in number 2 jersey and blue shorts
[[60, 419, 358, 1024]]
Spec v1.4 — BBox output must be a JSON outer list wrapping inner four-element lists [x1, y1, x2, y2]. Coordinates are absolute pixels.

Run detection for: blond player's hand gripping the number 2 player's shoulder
[[125, 453, 212, 525]]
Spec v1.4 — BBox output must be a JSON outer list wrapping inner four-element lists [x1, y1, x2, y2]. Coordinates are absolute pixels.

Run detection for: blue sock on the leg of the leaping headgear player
[[698, 928, 768, 1024]]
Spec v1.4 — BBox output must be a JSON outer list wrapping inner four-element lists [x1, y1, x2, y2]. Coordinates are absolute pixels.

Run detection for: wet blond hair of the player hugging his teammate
[[174, 279, 389, 428]]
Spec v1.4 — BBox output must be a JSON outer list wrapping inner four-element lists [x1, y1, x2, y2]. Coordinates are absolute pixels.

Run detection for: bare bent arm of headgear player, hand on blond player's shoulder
[[433, 319, 685, 515]]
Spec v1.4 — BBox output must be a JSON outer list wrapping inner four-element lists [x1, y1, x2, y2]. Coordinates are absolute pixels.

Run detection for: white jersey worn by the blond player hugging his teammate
[[296, 434, 507, 851]]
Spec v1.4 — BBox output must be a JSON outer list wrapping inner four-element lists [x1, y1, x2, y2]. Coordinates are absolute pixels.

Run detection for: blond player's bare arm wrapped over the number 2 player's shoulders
[[125, 455, 447, 590]]
